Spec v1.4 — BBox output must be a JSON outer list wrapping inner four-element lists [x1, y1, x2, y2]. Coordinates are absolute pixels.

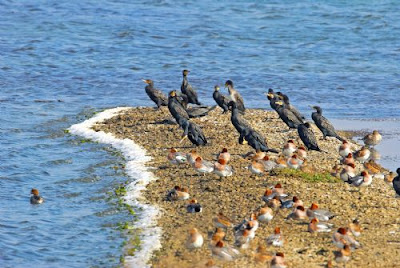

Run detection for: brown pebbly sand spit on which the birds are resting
[[94, 108, 400, 267]]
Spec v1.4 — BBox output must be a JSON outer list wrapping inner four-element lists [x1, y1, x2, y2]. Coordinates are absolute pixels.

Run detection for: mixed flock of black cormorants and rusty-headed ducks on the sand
[[143, 70, 400, 267]]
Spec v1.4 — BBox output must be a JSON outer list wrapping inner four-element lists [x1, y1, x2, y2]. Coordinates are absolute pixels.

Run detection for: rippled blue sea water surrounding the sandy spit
[[0, 0, 400, 267]]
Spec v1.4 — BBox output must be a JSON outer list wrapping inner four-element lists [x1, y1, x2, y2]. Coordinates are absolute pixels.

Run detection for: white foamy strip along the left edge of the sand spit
[[69, 107, 161, 267]]
